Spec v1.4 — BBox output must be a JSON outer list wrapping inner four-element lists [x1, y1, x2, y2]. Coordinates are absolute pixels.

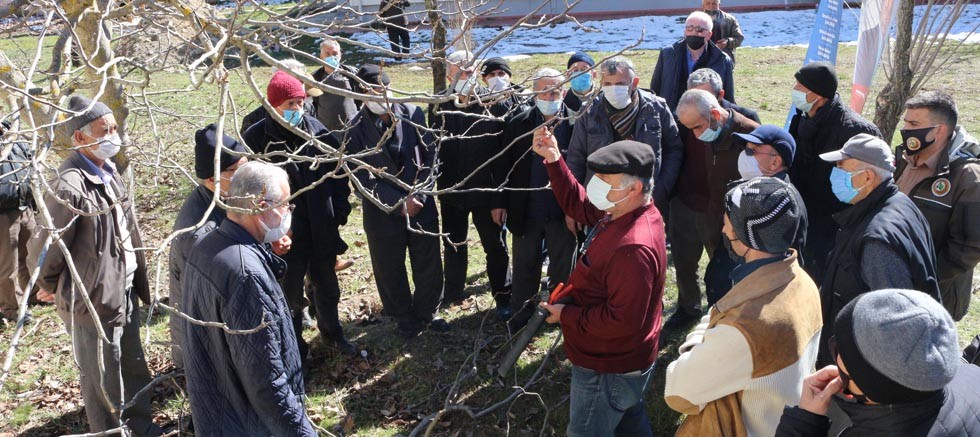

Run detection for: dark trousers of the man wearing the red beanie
[[282, 201, 344, 349]]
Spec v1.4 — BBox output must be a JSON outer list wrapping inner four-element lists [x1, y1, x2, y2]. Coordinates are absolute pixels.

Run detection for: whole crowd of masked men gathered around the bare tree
[[0, 0, 980, 436]]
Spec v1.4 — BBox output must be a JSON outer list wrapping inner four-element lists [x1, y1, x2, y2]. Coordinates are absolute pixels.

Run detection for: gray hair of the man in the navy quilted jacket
[[227, 161, 289, 214]]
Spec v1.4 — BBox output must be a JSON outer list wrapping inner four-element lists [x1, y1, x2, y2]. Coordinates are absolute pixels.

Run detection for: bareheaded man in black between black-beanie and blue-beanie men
[[491, 68, 576, 332]]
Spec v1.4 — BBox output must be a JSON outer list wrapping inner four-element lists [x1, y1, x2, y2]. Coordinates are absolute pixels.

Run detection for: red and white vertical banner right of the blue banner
[[851, 0, 898, 114]]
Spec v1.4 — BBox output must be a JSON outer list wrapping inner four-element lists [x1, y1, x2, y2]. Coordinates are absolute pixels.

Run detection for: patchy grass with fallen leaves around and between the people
[[0, 38, 980, 436]]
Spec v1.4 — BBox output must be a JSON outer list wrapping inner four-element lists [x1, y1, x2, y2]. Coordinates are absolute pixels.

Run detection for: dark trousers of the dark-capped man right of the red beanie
[[364, 205, 443, 322]]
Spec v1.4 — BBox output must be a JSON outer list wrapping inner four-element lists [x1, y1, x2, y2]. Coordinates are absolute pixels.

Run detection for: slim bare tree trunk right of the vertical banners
[[874, 0, 914, 143]]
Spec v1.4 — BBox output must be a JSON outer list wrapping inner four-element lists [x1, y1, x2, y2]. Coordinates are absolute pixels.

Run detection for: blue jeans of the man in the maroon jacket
[[565, 365, 654, 437]]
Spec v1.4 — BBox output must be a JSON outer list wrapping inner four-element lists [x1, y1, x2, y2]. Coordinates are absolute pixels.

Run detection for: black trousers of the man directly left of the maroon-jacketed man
[[510, 218, 577, 324]]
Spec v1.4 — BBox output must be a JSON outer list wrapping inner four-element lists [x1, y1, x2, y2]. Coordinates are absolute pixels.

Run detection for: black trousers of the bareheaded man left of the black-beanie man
[[440, 203, 510, 299]]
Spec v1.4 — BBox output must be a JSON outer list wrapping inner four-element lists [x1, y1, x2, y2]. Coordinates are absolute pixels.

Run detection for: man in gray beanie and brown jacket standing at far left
[[31, 95, 161, 435]]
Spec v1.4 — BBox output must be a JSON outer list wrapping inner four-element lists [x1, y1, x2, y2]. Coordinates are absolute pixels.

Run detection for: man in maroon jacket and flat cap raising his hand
[[533, 128, 667, 436]]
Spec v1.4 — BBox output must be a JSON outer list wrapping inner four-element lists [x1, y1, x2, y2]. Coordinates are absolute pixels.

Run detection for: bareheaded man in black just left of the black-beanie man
[[429, 51, 516, 308]]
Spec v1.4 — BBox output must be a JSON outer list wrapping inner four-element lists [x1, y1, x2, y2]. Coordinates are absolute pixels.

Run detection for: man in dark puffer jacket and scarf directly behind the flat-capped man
[[568, 56, 684, 213]]
